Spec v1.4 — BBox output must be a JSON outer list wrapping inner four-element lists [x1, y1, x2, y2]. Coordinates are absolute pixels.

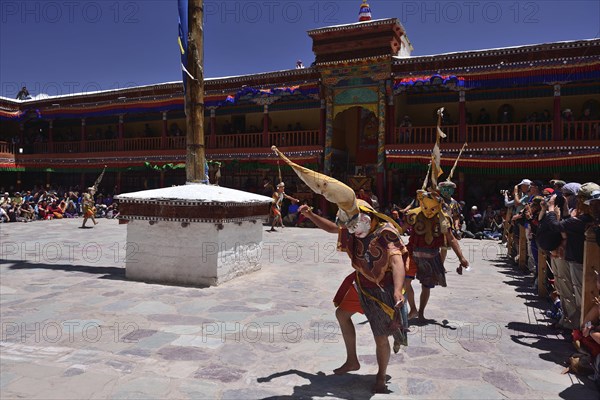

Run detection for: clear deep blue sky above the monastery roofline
[[0, 0, 600, 98]]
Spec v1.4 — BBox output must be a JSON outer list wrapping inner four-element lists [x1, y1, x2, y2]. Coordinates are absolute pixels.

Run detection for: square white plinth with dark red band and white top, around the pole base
[[117, 184, 272, 286]]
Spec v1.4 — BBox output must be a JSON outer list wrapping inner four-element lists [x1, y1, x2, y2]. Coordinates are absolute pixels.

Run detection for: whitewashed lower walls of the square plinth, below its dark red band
[[126, 218, 263, 286]]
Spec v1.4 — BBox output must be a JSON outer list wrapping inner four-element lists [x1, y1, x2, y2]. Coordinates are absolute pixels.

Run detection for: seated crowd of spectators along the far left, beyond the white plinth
[[0, 188, 119, 223]]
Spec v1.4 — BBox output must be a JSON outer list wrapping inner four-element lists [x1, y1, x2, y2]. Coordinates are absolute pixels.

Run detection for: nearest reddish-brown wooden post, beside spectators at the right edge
[[576, 228, 600, 325]]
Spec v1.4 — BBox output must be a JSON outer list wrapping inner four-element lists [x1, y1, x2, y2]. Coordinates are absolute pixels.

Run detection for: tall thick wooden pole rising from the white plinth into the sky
[[185, 0, 205, 183]]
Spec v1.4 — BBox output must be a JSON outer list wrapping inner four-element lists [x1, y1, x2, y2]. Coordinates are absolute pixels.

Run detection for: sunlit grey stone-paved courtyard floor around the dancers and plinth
[[0, 220, 598, 400]]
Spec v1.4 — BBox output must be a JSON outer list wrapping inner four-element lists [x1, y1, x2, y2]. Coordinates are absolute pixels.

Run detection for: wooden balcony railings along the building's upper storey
[[7, 121, 600, 156]]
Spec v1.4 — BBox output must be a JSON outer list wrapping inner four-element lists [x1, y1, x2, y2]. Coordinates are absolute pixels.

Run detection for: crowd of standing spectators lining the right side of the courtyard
[[505, 179, 600, 381]]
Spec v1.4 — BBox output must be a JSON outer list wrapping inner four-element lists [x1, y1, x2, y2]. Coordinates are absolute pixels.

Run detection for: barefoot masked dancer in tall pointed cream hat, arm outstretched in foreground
[[272, 146, 408, 393]]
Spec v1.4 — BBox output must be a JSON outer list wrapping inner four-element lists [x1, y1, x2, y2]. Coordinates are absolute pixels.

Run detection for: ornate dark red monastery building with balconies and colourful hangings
[[0, 8, 600, 209]]
